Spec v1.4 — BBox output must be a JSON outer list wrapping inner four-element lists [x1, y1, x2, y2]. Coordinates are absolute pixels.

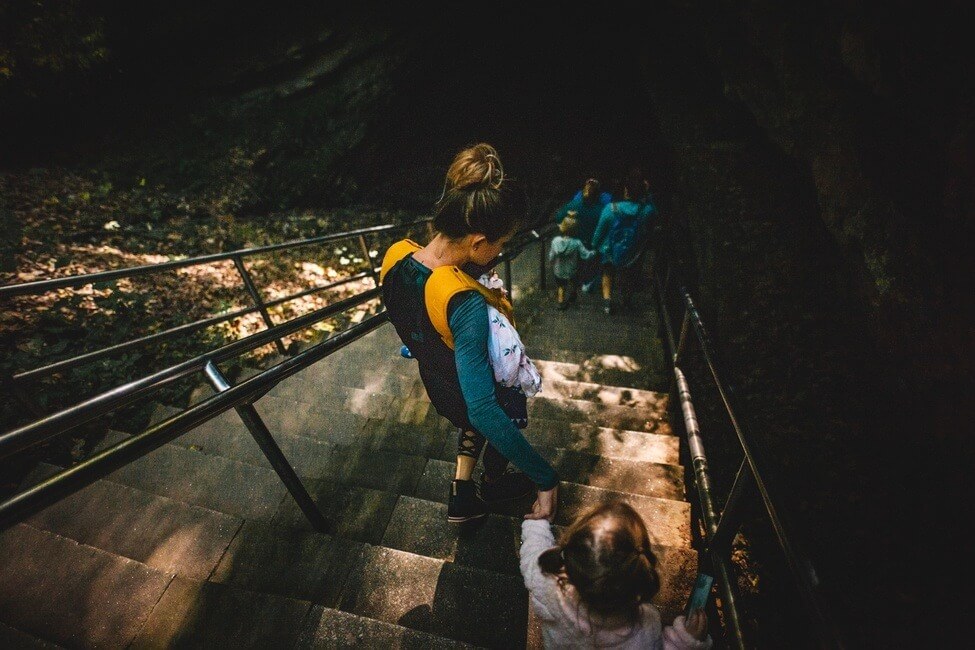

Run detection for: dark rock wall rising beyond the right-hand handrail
[[643, 0, 975, 645]]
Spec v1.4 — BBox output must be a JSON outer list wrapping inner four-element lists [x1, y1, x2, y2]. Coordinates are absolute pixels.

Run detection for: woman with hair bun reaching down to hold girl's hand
[[382, 143, 559, 523]]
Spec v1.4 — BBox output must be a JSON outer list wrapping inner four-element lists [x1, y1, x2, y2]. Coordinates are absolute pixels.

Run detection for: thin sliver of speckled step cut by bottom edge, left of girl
[[295, 606, 478, 650]]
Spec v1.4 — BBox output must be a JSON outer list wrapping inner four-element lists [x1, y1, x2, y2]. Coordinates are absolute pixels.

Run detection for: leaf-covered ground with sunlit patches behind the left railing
[[0, 163, 421, 488]]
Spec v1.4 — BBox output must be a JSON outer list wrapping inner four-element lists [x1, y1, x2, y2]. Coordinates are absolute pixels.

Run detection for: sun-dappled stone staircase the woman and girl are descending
[[0, 276, 696, 648]]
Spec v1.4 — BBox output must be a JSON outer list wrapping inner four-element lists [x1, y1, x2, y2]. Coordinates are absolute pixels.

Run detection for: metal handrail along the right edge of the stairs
[[654, 246, 847, 648]]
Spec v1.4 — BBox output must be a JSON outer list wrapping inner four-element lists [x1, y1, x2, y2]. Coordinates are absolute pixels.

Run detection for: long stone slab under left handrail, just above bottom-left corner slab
[[24, 464, 242, 580]]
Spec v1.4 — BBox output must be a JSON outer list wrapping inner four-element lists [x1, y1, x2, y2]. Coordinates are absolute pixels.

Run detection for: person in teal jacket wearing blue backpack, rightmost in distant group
[[592, 167, 656, 314]]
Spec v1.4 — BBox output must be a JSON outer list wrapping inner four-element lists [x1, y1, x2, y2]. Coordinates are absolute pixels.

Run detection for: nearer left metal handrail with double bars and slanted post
[[0, 220, 545, 532]]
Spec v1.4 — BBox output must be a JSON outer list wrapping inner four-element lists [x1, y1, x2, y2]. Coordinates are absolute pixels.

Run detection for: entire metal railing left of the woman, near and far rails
[[0, 219, 545, 532]]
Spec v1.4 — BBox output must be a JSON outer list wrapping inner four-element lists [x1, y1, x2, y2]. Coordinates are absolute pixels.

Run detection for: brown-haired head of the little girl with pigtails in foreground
[[538, 501, 660, 621]]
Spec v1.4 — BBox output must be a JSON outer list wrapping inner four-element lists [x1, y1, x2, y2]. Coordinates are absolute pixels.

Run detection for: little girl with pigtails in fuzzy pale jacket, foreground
[[521, 502, 712, 650]]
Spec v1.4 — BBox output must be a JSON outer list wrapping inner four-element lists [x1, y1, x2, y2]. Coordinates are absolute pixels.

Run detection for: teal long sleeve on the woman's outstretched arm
[[448, 291, 559, 490]]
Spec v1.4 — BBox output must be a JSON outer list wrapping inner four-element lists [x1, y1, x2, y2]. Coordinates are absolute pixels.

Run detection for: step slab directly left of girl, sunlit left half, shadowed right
[[340, 547, 528, 648]]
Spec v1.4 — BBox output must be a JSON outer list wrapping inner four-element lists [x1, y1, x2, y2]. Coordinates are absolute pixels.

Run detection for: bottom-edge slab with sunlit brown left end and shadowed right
[[129, 576, 312, 649]]
